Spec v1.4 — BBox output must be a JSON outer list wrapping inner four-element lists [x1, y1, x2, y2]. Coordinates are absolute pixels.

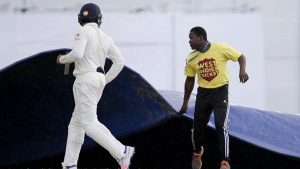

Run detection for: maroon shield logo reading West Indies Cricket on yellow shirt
[[198, 58, 219, 82]]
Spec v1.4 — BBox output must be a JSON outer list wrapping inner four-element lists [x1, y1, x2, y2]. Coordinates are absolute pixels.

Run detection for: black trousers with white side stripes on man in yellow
[[192, 84, 229, 160]]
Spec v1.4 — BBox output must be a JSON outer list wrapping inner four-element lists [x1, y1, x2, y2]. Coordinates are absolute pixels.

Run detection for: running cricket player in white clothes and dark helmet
[[57, 3, 135, 169]]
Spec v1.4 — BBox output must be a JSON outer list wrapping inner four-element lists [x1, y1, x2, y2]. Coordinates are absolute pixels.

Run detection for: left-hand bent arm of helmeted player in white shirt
[[56, 31, 87, 64]]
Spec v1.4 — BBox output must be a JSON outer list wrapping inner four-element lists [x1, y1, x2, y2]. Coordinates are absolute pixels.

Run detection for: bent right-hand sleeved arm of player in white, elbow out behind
[[105, 39, 124, 84]]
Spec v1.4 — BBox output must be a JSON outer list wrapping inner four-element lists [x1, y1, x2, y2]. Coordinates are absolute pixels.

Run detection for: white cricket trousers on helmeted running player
[[62, 72, 125, 167]]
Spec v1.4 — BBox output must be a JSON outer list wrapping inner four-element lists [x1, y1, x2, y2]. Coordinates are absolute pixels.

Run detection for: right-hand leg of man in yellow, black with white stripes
[[213, 85, 230, 161]]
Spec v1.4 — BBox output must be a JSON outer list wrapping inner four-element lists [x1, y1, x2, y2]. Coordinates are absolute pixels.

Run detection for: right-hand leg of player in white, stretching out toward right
[[78, 76, 125, 161]]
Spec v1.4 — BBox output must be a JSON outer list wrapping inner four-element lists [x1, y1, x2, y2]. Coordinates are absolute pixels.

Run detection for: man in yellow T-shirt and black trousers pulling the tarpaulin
[[180, 27, 249, 169]]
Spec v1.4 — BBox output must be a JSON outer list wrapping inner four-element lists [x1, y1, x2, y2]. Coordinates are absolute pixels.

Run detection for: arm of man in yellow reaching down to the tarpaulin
[[179, 77, 195, 114]]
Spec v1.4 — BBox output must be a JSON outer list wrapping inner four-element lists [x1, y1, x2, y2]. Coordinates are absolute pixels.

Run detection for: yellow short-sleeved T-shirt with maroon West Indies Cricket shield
[[185, 43, 241, 88]]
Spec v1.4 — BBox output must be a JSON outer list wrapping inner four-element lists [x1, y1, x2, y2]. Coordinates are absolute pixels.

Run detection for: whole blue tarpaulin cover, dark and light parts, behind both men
[[0, 49, 300, 167]]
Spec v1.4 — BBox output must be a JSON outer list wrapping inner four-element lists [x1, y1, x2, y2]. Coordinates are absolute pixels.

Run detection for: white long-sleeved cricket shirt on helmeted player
[[59, 23, 124, 83]]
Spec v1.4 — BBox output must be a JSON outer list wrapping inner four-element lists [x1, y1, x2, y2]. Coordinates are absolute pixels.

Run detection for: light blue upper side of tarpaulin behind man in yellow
[[160, 91, 300, 158]]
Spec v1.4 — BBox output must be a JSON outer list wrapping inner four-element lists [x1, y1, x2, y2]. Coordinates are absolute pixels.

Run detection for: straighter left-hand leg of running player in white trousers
[[62, 85, 85, 168]]
